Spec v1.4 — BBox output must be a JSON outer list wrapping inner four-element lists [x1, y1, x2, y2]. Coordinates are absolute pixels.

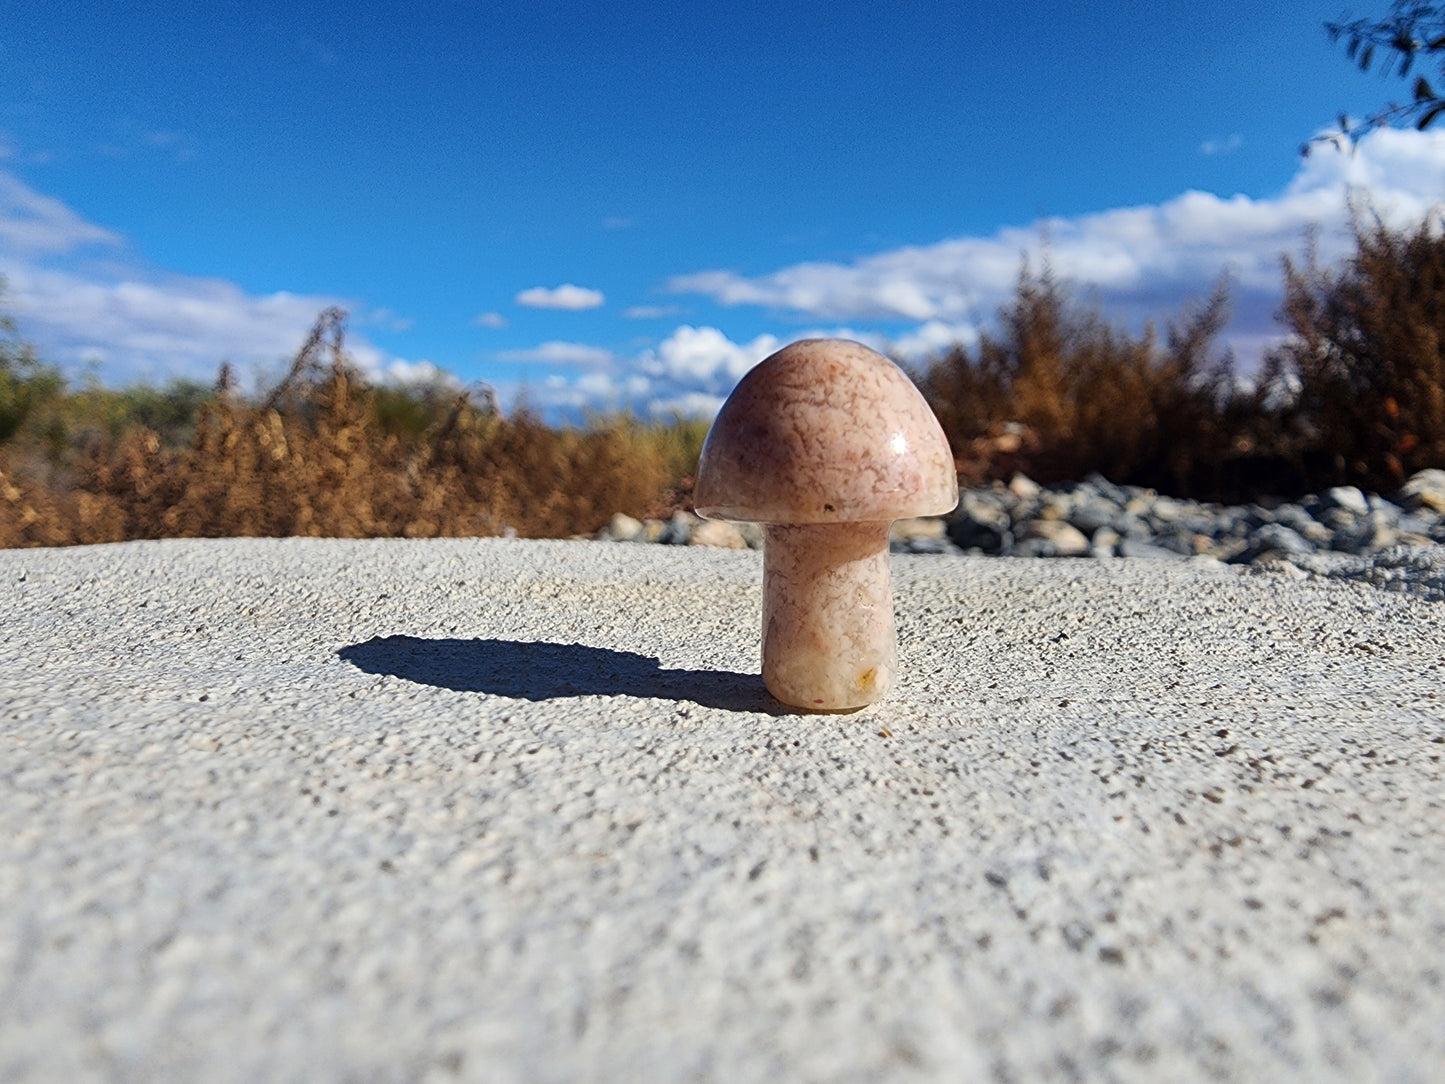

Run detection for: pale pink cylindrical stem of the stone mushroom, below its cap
[[763, 522, 897, 711]]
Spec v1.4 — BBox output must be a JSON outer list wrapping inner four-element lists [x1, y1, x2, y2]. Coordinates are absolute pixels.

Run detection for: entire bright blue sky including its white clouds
[[0, 0, 1445, 416]]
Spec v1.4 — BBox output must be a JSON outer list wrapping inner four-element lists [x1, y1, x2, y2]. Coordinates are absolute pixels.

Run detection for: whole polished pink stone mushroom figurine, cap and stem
[[694, 338, 958, 711]]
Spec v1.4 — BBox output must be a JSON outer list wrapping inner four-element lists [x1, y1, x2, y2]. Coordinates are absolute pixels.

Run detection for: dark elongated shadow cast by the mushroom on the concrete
[[337, 636, 798, 715]]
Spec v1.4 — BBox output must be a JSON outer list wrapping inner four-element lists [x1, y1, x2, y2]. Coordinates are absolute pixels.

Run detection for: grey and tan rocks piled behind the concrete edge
[[598, 470, 1445, 567]]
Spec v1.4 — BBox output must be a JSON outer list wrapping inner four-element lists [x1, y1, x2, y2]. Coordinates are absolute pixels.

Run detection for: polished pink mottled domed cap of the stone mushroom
[[694, 338, 958, 523]]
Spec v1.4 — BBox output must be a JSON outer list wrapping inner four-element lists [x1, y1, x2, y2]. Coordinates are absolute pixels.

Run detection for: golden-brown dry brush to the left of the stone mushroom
[[0, 311, 705, 546]]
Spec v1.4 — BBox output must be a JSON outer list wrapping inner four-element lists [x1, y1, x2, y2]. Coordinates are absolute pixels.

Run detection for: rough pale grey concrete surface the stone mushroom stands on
[[0, 539, 1445, 1081]]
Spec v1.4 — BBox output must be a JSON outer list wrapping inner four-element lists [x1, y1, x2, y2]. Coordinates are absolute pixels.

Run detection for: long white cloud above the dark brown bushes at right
[[668, 129, 1445, 370]]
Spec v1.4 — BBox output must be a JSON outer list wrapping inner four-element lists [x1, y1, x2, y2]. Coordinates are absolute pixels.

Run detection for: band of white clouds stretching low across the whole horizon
[[0, 129, 1445, 415]]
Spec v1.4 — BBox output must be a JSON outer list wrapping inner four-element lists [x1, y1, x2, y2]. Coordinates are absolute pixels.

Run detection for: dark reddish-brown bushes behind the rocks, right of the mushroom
[[916, 212, 1445, 500]]
